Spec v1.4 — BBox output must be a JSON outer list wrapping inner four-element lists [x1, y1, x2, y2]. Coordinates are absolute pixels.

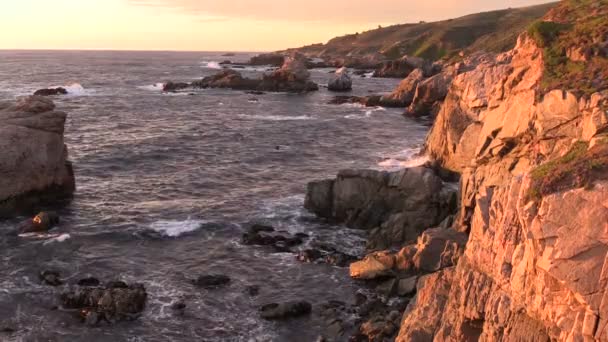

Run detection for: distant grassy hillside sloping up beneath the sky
[[288, 2, 557, 60]]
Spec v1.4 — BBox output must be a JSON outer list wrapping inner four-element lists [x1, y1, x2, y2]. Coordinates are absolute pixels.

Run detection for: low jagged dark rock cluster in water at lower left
[[61, 284, 148, 325]]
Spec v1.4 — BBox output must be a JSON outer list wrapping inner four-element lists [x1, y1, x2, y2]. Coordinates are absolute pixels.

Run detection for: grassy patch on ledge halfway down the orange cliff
[[529, 139, 608, 199]]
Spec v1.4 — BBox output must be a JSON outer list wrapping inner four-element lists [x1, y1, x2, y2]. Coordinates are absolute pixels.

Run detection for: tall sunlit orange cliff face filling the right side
[[397, 1, 608, 341]]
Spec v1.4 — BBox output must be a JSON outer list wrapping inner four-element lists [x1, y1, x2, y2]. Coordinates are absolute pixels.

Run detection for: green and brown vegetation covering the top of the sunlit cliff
[[528, 0, 608, 95]]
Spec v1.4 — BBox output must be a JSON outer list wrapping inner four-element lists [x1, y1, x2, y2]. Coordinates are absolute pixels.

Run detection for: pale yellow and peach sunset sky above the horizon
[[0, 0, 548, 51]]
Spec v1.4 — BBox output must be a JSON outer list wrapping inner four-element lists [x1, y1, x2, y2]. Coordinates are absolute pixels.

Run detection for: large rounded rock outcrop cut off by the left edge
[[0, 96, 75, 217]]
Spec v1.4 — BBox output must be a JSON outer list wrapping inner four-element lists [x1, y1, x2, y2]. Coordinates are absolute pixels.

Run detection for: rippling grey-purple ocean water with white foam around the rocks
[[0, 51, 428, 342]]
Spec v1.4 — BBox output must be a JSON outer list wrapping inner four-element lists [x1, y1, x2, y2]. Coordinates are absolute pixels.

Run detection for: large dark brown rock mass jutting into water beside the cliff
[[305, 167, 457, 249]]
